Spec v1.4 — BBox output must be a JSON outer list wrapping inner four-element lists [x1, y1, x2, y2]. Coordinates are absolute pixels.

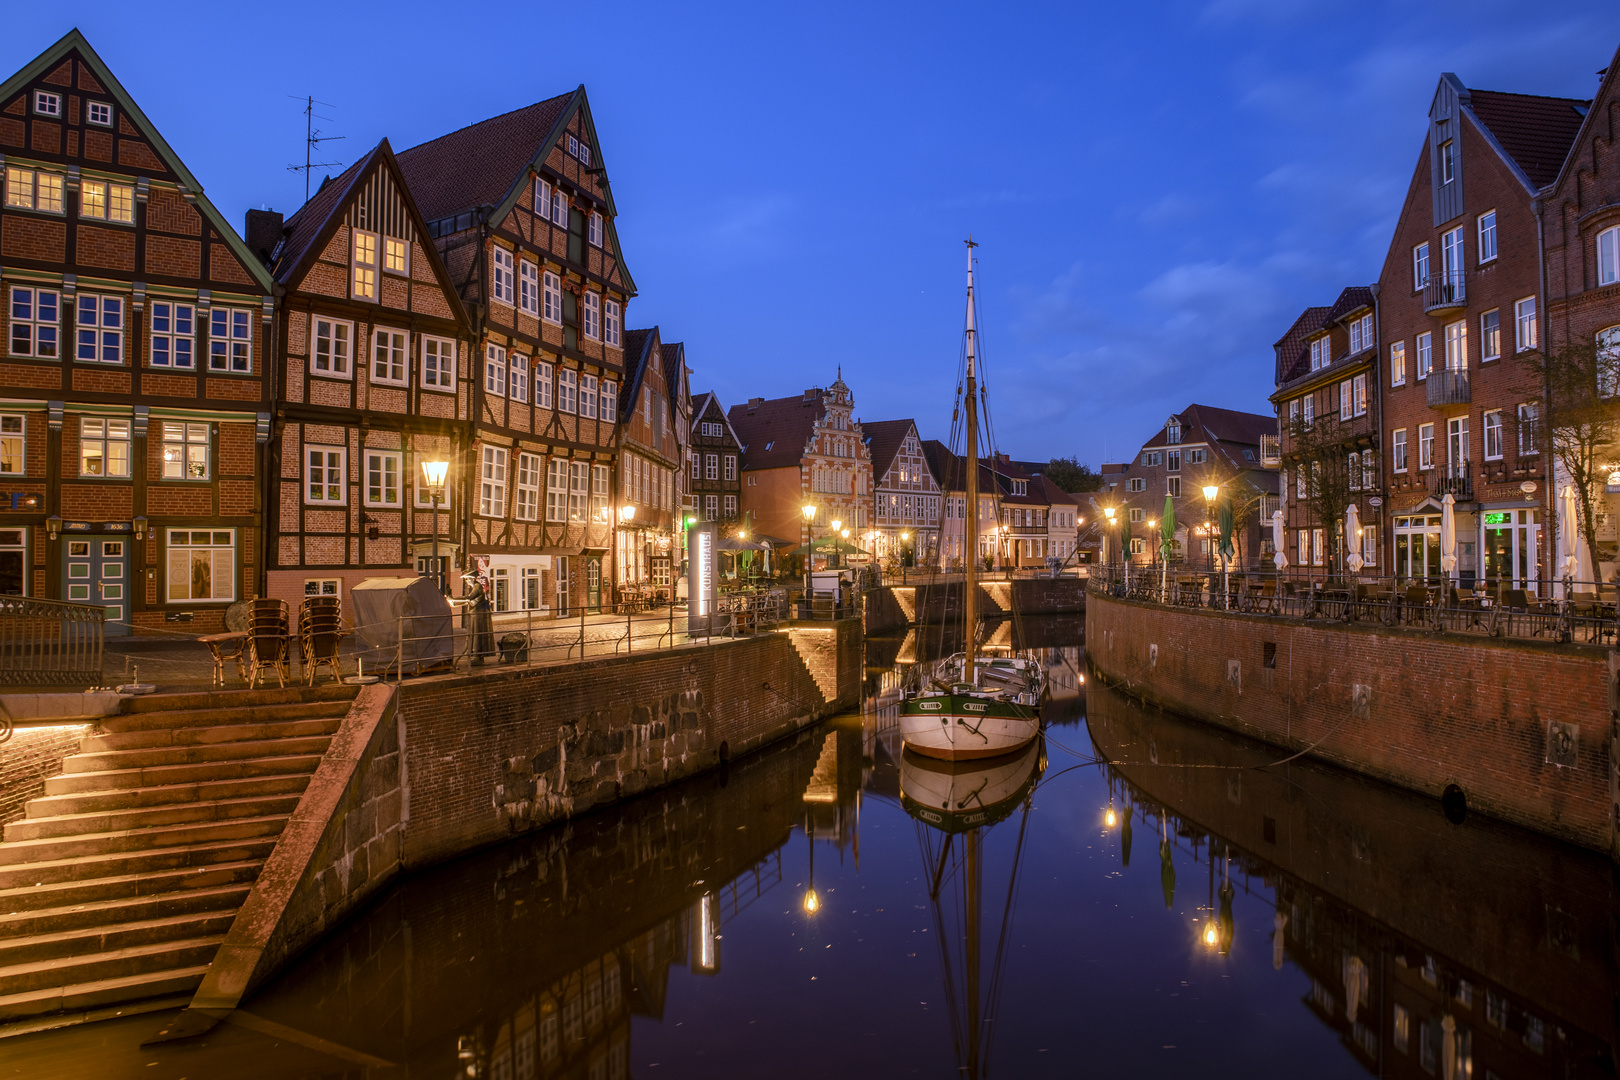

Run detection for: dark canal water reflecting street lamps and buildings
[[0, 623, 1617, 1080]]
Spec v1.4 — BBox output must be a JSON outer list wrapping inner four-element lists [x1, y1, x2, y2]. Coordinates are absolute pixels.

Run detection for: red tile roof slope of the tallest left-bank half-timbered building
[[397, 93, 585, 222]]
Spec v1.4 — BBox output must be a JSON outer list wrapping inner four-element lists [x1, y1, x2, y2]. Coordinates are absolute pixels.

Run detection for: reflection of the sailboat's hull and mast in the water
[[901, 738, 1047, 1080]]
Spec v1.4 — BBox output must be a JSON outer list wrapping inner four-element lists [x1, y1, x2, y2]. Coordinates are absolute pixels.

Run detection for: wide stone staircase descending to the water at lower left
[[0, 685, 355, 1025]]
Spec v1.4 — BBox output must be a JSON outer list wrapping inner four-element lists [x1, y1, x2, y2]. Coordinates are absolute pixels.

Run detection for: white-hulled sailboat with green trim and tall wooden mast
[[901, 240, 1045, 761]]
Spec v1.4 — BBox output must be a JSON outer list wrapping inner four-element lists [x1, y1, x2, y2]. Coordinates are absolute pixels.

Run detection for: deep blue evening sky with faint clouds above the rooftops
[[0, 0, 1620, 465]]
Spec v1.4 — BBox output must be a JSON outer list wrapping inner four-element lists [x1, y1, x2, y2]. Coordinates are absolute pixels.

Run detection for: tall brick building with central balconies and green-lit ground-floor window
[[1377, 74, 1586, 586]]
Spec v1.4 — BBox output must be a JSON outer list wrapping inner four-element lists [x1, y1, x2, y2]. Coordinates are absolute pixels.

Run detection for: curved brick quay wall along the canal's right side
[[1085, 593, 1615, 853]]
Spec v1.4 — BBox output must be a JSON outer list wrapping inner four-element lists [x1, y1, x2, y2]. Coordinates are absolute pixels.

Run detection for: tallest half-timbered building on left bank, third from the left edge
[[399, 86, 635, 615]]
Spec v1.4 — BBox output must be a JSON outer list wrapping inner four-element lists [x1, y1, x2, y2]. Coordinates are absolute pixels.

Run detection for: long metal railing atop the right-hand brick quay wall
[[1089, 565, 1620, 644]]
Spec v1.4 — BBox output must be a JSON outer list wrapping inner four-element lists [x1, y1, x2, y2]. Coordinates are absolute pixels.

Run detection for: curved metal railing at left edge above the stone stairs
[[0, 596, 107, 687]]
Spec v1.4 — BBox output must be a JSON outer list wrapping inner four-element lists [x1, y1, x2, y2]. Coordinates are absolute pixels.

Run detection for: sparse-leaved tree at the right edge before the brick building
[[1518, 340, 1620, 572]]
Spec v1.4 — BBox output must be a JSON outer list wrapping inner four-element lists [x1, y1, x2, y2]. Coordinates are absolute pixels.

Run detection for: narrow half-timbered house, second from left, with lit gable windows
[[248, 139, 476, 621]]
